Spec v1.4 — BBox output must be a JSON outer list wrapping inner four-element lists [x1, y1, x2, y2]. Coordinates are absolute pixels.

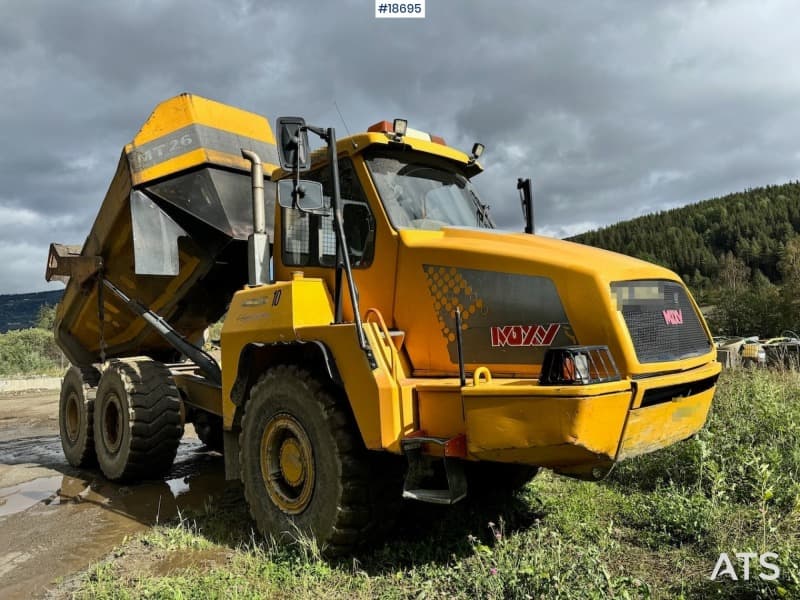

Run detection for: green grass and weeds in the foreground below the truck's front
[[65, 371, 800, 599]]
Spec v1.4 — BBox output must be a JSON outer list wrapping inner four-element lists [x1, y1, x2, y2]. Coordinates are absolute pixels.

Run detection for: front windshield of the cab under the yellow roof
[[366, 151, 494, 230]]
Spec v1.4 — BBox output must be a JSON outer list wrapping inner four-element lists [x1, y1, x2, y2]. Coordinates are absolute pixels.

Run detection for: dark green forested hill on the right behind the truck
[[570, 181, 800, 287]]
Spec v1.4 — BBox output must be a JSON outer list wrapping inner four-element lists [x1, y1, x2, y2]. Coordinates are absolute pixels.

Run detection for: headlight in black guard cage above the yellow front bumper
[[539, 346, 620, 385]]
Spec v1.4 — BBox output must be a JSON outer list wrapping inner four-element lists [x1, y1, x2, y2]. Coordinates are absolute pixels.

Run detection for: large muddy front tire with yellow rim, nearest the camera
[[239, 366, 402, 556]]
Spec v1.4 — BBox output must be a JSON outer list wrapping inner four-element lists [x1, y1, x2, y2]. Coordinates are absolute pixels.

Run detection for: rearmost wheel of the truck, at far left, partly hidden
[[58, 366, 97, 467]]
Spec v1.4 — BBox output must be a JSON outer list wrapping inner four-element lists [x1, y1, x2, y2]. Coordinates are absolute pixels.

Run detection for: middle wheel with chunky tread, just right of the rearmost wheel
[[94, 358, 183, 481]]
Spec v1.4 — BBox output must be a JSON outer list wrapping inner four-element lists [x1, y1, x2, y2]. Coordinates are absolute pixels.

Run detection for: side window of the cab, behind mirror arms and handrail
[[281, 159, 375, 268]]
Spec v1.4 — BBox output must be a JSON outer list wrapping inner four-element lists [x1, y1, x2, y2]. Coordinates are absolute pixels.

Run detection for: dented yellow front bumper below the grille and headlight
[[462, 361, 720, 478]]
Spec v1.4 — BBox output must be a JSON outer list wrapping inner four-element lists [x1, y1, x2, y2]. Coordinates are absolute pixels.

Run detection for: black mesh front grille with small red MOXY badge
[[611, 280, 711, 363]]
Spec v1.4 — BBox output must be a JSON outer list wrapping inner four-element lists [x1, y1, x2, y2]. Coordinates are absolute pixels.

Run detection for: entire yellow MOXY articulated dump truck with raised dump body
[[47, 94, 720, 553]]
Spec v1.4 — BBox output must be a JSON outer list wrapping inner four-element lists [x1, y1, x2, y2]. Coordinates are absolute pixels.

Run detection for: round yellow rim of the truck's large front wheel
[[261, 414, 314, 515]]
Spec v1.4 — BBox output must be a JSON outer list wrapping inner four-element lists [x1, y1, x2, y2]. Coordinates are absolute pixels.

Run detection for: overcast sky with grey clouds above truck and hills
[[0, 0, 800, 293]]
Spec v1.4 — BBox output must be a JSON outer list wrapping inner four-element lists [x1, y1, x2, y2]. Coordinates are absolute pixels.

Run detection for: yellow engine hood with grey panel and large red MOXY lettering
[[394, 228, 707, 375]]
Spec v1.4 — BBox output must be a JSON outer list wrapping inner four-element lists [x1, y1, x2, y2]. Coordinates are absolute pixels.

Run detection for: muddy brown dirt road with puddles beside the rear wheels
[[0, 391, 224, 599]]
